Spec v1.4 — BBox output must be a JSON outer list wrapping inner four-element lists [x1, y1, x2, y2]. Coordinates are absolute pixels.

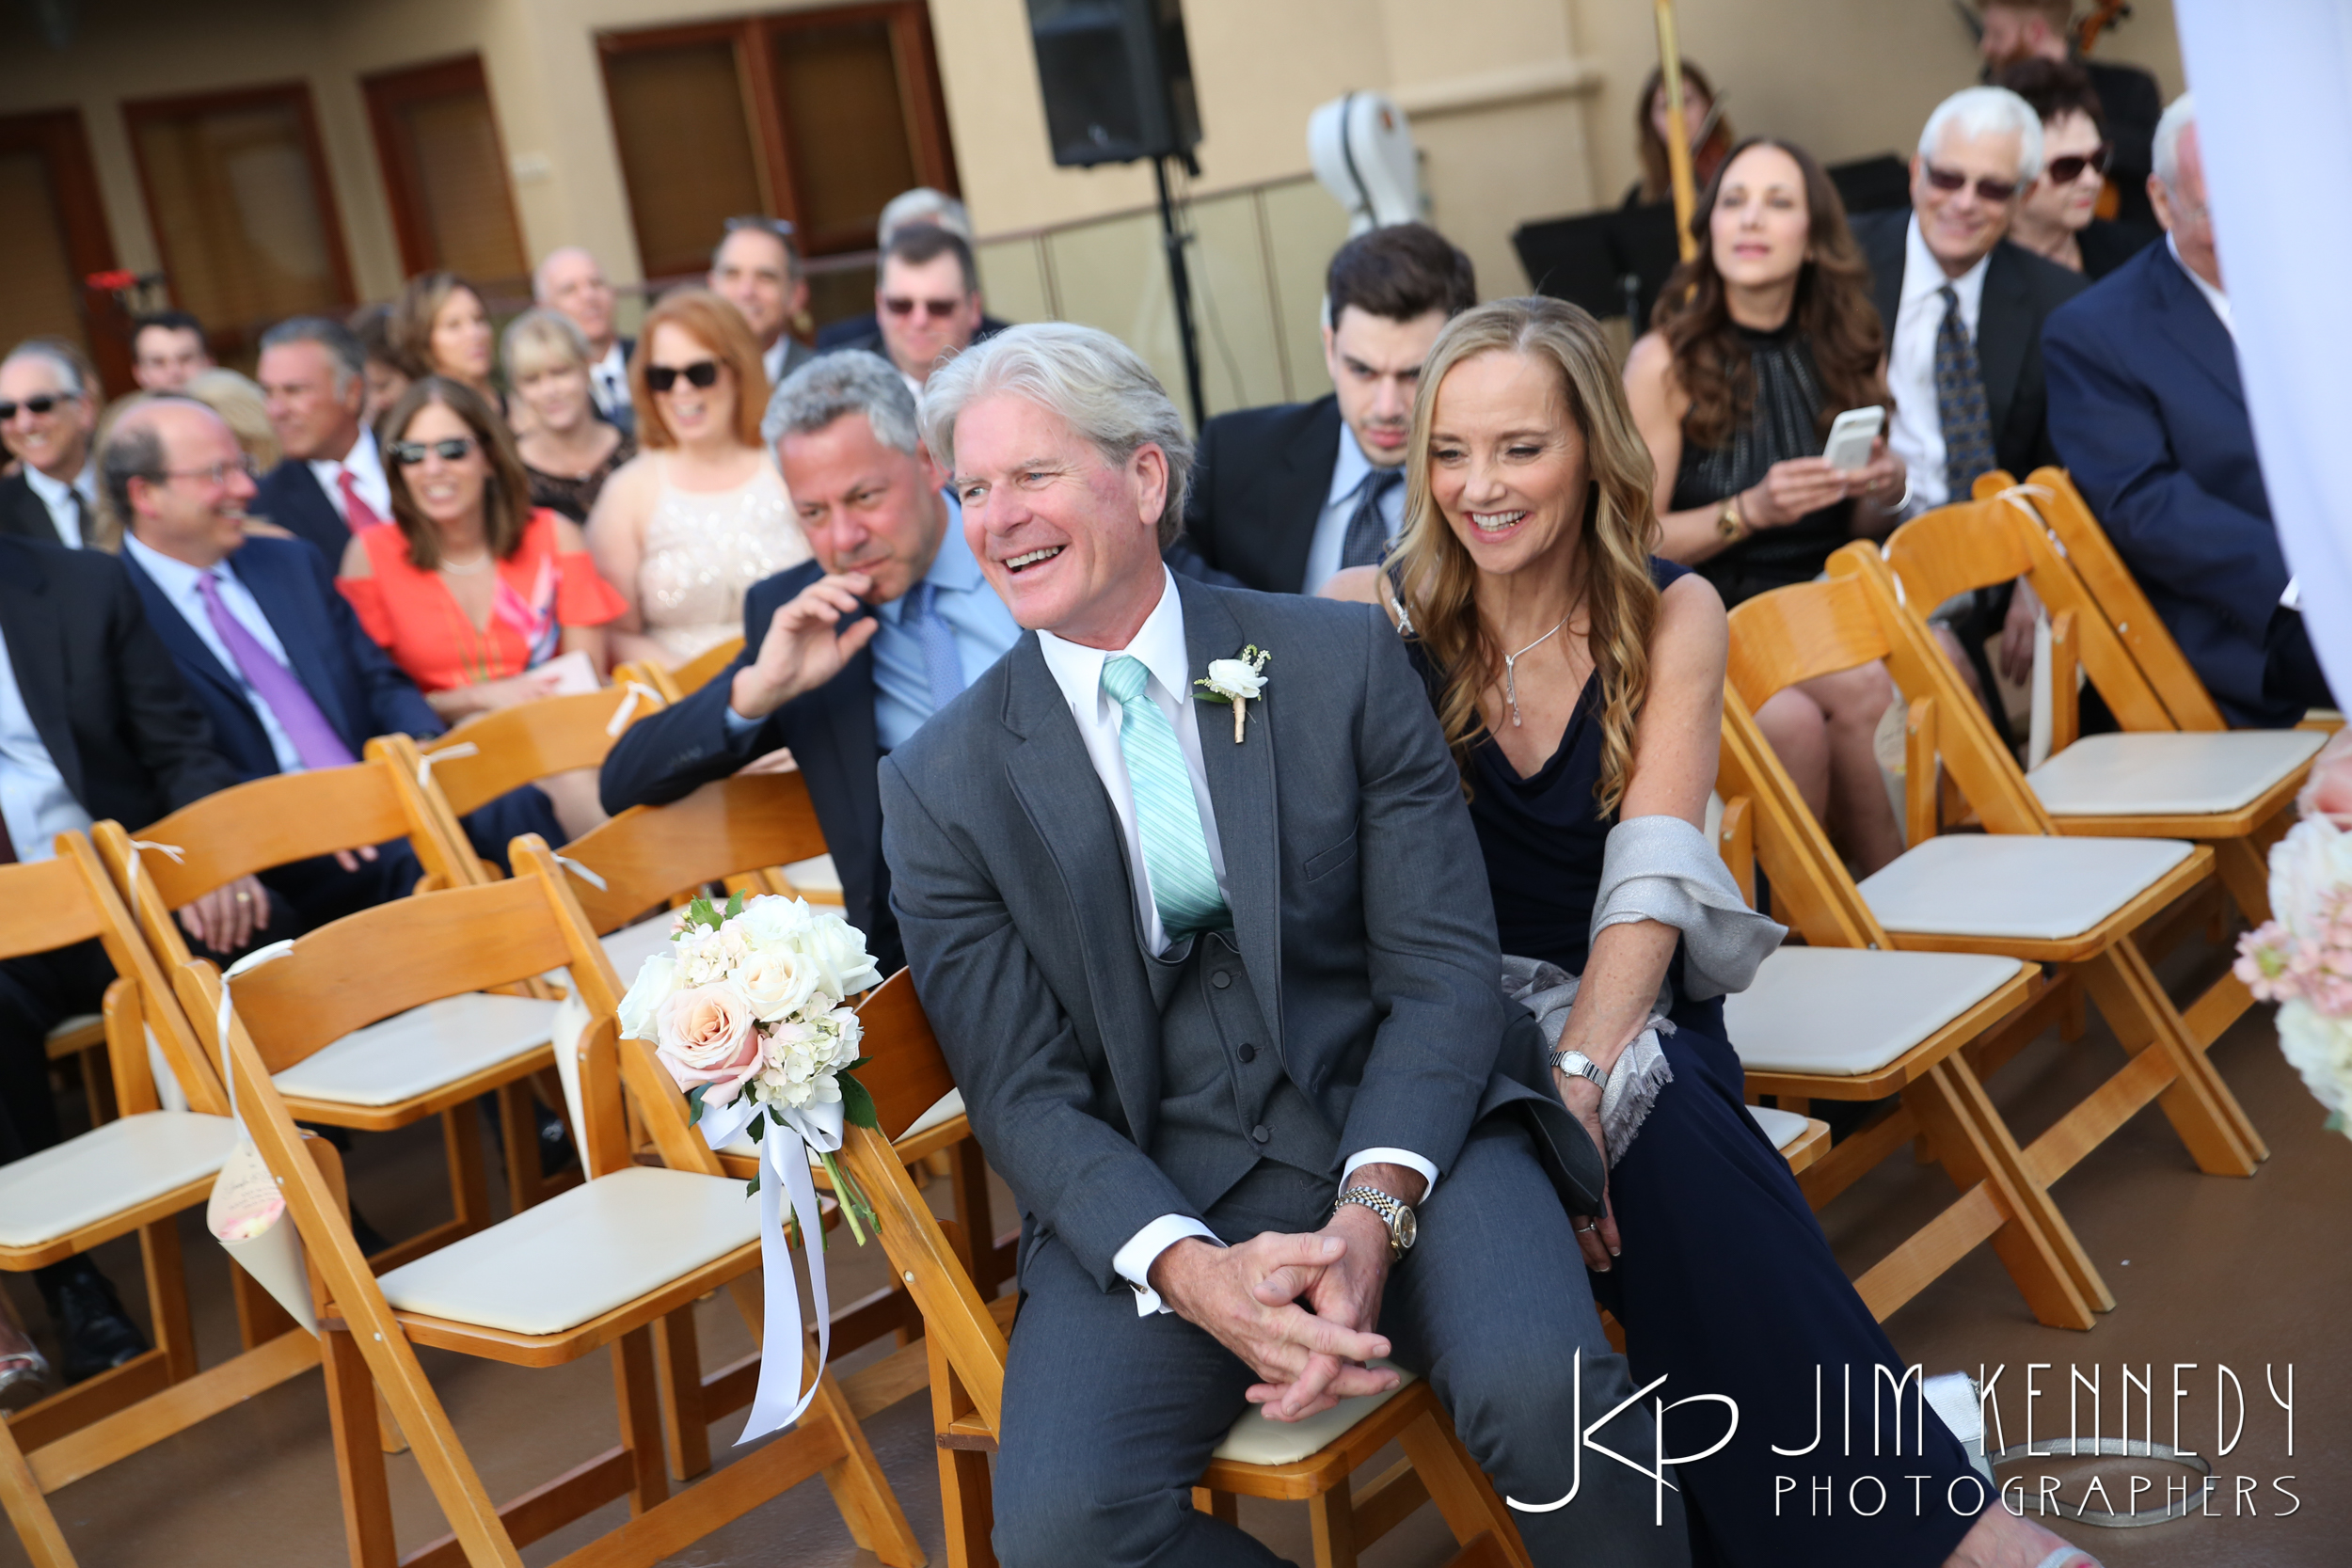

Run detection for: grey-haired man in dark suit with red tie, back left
[[252, 315, 393, 569]]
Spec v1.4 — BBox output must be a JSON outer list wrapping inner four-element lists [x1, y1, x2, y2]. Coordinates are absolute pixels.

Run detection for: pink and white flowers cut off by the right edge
[[2237, 731, 2352, 1135]]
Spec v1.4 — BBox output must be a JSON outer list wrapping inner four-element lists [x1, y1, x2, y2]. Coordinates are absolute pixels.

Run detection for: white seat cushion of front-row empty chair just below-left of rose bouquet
[[381, 1166, 760, 1333]]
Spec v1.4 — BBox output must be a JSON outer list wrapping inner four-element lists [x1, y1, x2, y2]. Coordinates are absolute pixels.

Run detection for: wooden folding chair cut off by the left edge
[[0, 832, 318, 1568]]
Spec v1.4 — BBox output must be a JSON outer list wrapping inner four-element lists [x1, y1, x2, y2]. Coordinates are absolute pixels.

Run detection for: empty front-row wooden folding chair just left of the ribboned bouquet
[[179, 875, 922, 1568]]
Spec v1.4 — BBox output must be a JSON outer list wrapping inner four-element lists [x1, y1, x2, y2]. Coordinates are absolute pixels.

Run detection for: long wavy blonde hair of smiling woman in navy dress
[[1391, 298, 1659, 816]]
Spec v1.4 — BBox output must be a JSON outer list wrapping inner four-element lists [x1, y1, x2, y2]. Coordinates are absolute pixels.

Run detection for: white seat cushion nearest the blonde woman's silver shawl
[[1724, 947, 2026, 1081]]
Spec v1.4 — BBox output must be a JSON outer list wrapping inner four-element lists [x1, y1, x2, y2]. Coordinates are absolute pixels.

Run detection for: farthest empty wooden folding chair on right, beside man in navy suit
[[1853, 502, 2327, 1049]]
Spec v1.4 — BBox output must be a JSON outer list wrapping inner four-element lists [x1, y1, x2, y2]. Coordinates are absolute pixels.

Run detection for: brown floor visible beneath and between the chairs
[[0, 926, 2352, 1568]]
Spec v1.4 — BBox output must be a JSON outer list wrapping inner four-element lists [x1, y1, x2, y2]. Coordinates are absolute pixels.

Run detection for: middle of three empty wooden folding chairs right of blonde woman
[[1729, 563, 2267, 1317]]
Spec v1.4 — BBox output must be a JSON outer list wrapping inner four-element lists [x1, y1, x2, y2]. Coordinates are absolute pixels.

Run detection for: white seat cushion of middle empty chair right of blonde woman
[[1861, 832, 2192, 941]]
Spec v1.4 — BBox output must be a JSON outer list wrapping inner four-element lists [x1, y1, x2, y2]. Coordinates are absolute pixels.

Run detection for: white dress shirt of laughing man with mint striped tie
[[1038, 566, 1438, 1317]]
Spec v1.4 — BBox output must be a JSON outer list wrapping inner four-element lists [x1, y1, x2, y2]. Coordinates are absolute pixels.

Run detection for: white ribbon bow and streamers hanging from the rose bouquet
[[699, 1093, 845, 1449]]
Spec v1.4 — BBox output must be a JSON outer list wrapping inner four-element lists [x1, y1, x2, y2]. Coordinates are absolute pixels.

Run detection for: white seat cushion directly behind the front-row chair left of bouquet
[[273, 992, 555, 1105]]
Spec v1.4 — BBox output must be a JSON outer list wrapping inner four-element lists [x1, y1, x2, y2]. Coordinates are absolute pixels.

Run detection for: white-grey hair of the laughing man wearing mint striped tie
[[922, 322, 1193, 547]]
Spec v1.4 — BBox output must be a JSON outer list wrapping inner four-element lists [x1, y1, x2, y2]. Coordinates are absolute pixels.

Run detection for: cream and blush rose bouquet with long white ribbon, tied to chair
[[621, 894, 882, 1444]]
